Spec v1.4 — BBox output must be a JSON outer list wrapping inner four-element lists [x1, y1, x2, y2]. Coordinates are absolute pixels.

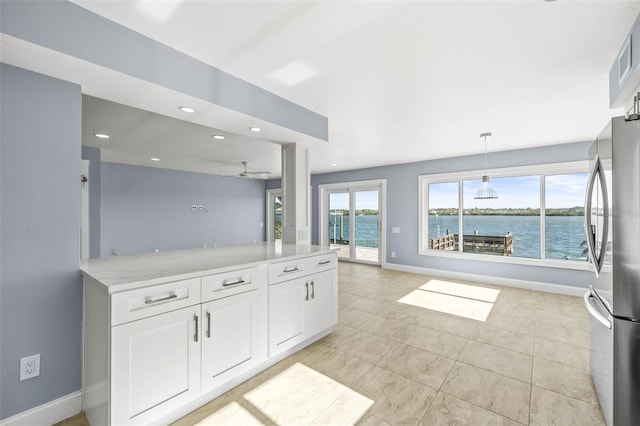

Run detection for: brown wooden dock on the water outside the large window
[[429, 231, 513, 256]]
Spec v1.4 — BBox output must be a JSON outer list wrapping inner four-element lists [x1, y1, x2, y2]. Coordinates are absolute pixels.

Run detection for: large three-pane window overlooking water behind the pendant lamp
[[420, 162, 588, 261]]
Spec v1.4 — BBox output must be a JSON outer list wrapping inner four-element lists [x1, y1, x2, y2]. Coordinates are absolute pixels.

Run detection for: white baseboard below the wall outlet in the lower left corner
[[0, 391, 82, 426]]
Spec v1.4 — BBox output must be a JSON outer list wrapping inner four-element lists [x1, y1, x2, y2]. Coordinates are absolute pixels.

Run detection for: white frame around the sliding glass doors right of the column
[[318, 179, 387, 268]]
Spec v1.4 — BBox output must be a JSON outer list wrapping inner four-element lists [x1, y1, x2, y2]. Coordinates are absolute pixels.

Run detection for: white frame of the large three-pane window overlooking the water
[[418, 161, 590, 271]]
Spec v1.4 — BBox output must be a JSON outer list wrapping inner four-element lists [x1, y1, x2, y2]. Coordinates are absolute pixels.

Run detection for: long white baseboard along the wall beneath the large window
[[384, 263, 587, 296]]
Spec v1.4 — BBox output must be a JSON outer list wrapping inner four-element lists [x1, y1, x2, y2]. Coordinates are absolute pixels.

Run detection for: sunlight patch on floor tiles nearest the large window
[[398, 280, 500, 321]]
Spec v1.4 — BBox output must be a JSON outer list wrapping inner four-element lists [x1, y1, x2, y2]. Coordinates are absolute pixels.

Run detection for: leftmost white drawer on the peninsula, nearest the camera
[[111, 278, 200, 326]]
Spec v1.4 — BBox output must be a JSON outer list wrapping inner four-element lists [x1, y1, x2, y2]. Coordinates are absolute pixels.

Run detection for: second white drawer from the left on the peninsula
[[202, 265, 267, 302]]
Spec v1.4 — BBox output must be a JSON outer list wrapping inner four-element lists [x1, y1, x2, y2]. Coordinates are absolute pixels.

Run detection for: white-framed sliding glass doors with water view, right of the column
[[319, 181, 386, 265]]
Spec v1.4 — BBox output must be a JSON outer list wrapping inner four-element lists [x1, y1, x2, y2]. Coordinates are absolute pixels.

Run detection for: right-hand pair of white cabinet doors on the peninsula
[[269, 255, 338, 356]]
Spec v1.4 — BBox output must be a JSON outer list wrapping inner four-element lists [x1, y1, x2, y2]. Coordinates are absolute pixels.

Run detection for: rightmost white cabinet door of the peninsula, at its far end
[[304, 270, 336, 337]]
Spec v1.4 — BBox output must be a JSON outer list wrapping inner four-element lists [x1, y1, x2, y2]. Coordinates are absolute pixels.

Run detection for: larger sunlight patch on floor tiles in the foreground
[[244, 363, 373, 425]]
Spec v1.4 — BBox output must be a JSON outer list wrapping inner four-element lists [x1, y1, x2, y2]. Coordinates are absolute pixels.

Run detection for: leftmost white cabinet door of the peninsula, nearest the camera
[[110, 305, 200, 425]]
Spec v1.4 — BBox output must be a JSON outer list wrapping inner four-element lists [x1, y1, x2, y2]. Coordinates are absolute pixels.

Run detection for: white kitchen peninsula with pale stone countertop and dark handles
[[81, 243, 338, 425]]
